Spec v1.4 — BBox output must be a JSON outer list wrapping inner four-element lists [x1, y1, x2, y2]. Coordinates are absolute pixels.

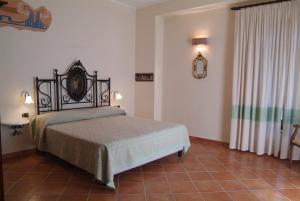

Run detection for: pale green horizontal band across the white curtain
[[231, 105, 300, 124]]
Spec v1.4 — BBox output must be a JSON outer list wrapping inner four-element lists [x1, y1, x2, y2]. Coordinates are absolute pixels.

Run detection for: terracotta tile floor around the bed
[[4, 139, 300, 201]]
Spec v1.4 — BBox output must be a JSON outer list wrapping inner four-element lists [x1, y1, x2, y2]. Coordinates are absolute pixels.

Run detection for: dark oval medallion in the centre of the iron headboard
[[67, 68, 87, 101]]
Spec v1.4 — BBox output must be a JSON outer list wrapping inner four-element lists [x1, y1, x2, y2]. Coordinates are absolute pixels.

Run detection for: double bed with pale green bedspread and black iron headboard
[[30, 62, 190, 189]]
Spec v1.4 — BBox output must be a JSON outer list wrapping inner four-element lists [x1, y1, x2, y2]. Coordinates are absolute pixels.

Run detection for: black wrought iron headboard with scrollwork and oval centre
[[35, 61, 110, 114]]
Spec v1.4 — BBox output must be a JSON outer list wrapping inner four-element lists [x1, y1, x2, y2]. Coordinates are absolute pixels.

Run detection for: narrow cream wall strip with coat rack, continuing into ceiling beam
[[135, 0, 246, 118]]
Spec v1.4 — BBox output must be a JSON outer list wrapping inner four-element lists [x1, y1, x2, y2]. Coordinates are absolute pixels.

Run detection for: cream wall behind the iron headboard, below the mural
[[0, 0, 135, 153]]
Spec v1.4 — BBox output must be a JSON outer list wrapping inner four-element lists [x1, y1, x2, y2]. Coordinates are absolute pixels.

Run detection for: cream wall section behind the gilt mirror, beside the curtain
[[162, 7, 234, 141]]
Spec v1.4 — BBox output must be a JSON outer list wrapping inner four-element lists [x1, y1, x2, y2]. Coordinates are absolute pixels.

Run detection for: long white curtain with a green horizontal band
[[230, 0, 300, 158]]
